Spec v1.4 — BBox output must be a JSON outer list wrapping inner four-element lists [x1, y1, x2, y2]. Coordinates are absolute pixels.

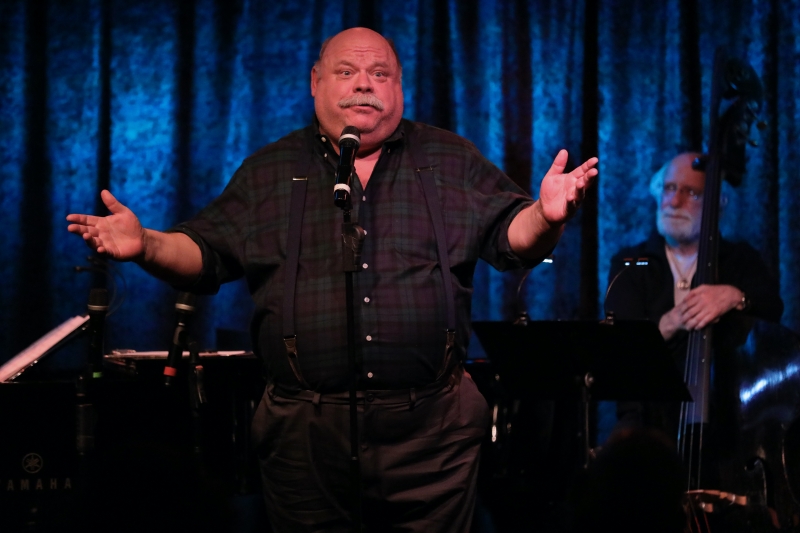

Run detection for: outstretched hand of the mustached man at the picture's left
[[67, 190, 146, 261]]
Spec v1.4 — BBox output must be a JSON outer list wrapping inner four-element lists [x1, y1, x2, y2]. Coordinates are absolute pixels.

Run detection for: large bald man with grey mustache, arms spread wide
[[67, 28, 597, 532]]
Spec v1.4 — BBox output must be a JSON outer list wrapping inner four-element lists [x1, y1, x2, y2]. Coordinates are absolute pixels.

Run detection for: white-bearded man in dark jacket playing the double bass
[[605, 152, 783, 438]]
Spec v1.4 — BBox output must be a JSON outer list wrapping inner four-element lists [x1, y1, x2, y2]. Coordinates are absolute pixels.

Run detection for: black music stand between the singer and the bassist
[[472, 320, 691, 468]]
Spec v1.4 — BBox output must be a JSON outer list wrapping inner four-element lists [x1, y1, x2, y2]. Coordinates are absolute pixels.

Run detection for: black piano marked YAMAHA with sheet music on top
[[0, 315, 265, 532]]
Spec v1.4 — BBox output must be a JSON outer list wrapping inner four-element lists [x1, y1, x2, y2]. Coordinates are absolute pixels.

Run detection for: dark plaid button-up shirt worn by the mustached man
[[174, 120, 532, 392]]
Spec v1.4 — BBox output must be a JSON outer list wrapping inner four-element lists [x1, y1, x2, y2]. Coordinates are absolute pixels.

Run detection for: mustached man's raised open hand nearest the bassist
[[539, 150, 597, 225]]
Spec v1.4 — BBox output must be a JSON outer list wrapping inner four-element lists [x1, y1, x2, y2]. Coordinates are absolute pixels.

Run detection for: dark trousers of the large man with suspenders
[[253, 368, 489, 533]]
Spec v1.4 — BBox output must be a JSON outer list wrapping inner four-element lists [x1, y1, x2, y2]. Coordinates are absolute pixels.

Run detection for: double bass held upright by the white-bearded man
[[677, 49, 800, 532]]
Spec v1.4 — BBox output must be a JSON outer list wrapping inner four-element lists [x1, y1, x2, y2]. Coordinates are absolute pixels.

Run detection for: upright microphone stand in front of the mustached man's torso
[[342, 184, 366, 533]]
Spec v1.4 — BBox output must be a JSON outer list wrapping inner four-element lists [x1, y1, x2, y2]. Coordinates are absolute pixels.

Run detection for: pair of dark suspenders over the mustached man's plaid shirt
[[283, 131, 456, 389]]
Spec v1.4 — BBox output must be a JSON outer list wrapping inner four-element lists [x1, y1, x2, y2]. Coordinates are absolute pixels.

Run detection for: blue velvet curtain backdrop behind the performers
[[0, 0, 800, 370]]
